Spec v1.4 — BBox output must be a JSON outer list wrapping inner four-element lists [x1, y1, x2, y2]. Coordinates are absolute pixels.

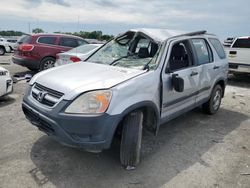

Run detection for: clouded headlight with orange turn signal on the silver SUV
[[65, 90, 112, 114]]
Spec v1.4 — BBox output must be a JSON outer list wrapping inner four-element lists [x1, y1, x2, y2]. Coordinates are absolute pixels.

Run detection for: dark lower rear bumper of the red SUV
[[12, 55, 39, 69]]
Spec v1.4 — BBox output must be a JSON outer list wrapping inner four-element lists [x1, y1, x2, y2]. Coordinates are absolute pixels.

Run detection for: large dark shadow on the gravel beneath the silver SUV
[[29, 109, 248, 188]]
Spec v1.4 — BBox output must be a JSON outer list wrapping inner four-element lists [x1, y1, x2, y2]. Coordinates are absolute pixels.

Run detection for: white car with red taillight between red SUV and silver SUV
[[55, 44, 103, 66]]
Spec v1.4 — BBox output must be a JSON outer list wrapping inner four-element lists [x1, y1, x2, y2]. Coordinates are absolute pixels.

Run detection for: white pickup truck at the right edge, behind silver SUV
[[225, 36, 250, 75]]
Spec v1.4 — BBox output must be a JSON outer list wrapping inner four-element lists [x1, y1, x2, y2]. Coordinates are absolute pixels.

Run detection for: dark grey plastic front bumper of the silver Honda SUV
[[22, 86, 120, 151]]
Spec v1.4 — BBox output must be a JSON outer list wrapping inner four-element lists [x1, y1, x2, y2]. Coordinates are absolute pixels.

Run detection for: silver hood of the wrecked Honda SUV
[[30, 62, 146, 100]]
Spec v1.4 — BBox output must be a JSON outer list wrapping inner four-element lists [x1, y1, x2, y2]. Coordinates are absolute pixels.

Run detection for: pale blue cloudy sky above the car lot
[[0, 0, 250, 39]]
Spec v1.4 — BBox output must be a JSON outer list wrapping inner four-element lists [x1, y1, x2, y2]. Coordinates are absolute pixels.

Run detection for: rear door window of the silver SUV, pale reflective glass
[[191, 39, 213, 65]]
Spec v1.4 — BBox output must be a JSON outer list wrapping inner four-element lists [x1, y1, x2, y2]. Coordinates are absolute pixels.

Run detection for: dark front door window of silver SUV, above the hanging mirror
[[169, 41, 192, 71]]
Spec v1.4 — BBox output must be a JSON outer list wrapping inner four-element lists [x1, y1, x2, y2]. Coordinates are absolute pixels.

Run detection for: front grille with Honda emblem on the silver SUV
[[31, 83, 64, 107]]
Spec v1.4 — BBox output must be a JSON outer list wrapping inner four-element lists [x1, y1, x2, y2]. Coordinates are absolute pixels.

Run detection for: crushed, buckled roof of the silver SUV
[[122, 28, 211, 42]]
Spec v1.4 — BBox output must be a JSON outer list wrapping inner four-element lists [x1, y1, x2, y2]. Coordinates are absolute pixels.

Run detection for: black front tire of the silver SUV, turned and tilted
[[120, 111, 143, 170]]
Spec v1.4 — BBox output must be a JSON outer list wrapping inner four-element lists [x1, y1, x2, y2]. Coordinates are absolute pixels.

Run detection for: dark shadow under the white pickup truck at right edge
[[228, 74, 250, 88]]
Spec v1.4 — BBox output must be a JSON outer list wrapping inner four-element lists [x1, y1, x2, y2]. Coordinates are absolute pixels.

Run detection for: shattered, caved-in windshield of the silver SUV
[[87, 32, 159, 69]]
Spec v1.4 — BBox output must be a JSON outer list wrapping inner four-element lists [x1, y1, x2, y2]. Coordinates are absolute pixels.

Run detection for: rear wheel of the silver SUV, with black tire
[[202, 85, 222, 115]]
